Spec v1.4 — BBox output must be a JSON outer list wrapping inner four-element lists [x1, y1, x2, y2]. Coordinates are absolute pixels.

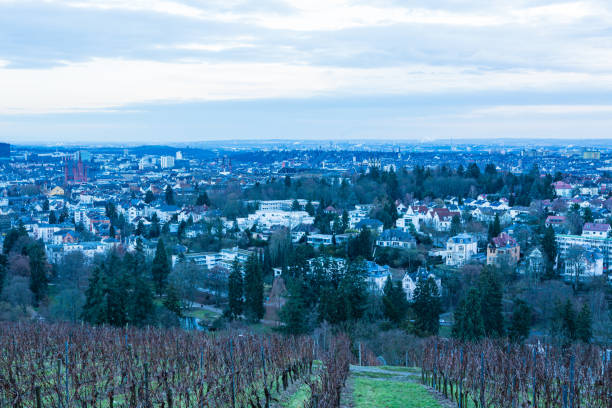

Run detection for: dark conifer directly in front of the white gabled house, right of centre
[[413, 276, 442, 335]]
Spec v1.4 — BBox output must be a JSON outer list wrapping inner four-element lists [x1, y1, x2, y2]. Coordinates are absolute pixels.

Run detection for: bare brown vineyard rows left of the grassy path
[[0, 323, 351, 408]]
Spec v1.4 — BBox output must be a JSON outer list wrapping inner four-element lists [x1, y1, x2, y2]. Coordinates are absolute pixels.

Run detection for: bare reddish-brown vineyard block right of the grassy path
[[421, 339, 612, 408]]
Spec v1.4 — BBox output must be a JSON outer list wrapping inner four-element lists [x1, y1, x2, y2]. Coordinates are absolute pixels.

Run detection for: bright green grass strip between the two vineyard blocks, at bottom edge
[[353, 377, 441, 408]]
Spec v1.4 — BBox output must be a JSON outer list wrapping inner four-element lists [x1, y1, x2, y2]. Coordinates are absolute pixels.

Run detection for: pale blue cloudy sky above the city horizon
[[0, 0, 612, 145]]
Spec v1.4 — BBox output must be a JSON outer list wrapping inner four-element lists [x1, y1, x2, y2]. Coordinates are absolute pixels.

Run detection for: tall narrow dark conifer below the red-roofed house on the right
[[479, 268, 504, 337]]
